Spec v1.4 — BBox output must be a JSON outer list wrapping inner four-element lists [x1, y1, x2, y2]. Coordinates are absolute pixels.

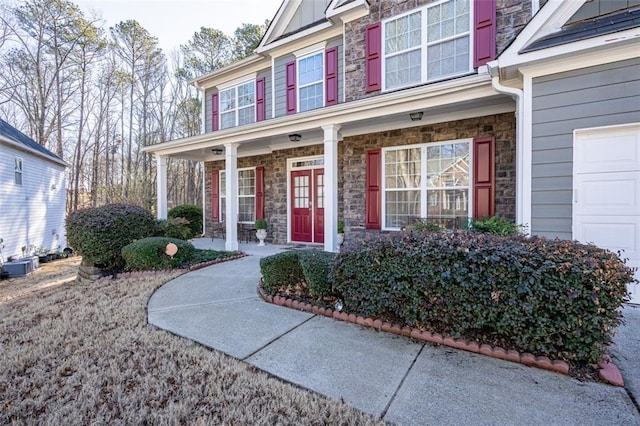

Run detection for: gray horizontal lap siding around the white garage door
[[530, 58, 640, 239]]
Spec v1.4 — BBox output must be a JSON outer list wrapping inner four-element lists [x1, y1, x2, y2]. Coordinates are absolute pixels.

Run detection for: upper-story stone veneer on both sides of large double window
[[344, 0, 531, 102]]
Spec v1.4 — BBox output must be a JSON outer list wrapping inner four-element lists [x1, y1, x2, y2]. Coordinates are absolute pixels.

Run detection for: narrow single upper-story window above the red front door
[[298, 52, 324, 112]]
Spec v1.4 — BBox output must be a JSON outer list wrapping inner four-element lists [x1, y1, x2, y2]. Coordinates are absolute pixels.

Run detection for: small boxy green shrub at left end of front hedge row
[[260, 251, 304, 293]]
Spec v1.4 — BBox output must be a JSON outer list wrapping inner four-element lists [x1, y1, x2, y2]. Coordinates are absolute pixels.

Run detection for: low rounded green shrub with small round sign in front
[[122, 237, 196, 271]]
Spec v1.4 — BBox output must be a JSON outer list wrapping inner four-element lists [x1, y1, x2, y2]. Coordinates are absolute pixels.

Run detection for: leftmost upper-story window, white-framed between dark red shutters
[[219, 80, 256, 129]]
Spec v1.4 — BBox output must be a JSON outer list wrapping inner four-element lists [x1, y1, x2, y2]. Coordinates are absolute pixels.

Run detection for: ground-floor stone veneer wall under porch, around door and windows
[[205, 113, 516, 244]]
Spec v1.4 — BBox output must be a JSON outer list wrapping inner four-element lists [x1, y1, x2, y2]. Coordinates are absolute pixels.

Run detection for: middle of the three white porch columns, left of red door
[[224, 143, 238, 251]]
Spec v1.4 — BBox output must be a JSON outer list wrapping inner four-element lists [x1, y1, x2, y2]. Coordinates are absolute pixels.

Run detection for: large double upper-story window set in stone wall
[[383, 0, 473, 90]]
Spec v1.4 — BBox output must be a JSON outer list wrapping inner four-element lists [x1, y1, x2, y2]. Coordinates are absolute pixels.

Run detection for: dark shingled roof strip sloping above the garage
[[519, 7, 640, 53]]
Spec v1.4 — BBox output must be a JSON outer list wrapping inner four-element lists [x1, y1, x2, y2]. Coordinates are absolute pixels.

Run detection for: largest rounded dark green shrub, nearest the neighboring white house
[[67, 204, 156, 268]]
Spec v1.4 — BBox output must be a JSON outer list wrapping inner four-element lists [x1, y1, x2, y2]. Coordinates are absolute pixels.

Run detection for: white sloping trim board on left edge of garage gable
[[498, 0, 585, 66]]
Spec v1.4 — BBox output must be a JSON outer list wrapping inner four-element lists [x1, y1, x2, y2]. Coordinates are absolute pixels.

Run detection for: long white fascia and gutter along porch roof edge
[[142, 74, 497, 155]]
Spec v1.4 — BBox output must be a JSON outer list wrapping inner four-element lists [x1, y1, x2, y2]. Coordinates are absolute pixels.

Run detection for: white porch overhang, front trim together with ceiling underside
[[145, 76, 515, 161]]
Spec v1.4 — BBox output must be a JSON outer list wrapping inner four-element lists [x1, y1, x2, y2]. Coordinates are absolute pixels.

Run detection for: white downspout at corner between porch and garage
[[487, 61, 530, 234]]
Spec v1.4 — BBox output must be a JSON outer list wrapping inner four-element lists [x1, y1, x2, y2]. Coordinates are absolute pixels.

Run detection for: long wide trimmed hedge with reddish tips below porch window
[[333, 231, 634, 363]]
